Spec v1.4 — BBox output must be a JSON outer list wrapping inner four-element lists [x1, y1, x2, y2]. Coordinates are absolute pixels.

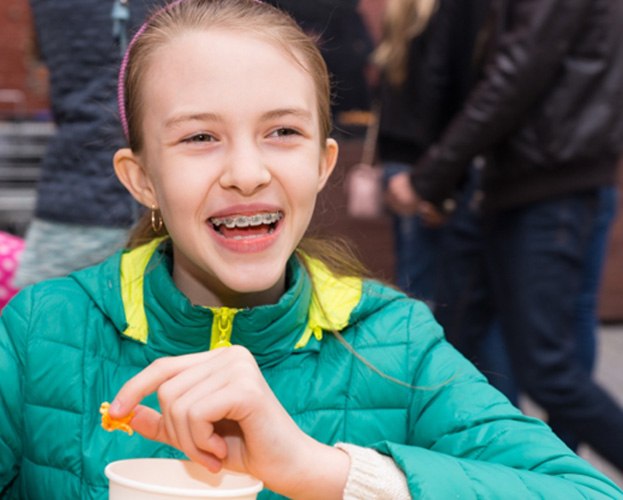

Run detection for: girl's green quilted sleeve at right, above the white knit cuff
[[377, 298, 623, 499]]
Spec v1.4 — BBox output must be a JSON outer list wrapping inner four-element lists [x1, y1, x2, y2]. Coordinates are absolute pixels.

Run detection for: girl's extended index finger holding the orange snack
[[108, 349, 222, 419]]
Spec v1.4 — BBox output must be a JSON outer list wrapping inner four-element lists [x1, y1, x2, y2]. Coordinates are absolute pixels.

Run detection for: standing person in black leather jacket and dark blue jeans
[[392, 0, 623, 470]]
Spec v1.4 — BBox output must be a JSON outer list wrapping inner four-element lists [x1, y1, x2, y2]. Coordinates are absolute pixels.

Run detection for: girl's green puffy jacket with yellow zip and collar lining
[[0, 240, 623, 500]]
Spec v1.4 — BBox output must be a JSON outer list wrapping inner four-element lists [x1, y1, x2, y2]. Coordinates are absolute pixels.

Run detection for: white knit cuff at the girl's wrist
[[335, 443, 411, 500]]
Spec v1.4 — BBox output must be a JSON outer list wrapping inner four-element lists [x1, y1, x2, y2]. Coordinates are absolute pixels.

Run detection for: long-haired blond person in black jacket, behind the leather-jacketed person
[[374, 0, 518, 404]]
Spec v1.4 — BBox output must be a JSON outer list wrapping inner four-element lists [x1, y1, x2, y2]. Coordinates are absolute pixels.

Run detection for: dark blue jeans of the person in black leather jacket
[[483, 190, 623, 470]]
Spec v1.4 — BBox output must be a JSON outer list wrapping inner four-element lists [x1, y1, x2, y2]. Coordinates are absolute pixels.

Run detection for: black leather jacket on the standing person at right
[[414, 0, 623, 213]]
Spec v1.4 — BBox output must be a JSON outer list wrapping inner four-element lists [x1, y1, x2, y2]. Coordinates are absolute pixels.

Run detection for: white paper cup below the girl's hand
[[104, 458, 263, 500]]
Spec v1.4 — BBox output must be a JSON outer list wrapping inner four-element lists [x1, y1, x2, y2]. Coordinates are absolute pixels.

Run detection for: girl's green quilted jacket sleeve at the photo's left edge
[[0, 292, 28, 497]]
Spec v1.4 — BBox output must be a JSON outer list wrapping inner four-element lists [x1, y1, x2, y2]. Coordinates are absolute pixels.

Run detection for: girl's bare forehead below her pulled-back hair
[[142, 29, 316, 112]]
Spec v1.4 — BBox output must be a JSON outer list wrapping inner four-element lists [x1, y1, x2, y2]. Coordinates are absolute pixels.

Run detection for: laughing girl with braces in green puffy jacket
[[0, 0, 621, 499]]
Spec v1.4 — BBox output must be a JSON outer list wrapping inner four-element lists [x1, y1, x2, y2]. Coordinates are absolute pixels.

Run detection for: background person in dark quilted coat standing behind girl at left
[[14, 0, 158, 287]]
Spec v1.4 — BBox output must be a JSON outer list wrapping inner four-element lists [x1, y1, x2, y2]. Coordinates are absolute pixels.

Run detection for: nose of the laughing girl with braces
[[220, 140, 271, 196]]
